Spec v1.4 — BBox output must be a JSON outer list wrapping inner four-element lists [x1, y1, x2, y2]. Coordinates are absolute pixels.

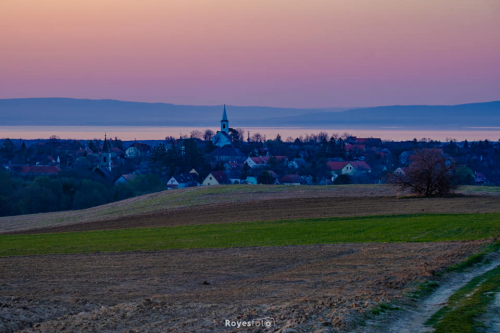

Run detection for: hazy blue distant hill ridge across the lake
[[0, 98, 500, 129]]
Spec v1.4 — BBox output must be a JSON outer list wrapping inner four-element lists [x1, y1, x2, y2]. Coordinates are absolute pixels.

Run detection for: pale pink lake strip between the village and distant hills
[[0, 126, 500, 141]]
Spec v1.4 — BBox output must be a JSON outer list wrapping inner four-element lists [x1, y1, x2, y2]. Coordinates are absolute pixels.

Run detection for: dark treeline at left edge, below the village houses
[[0, 171, 165, 216]]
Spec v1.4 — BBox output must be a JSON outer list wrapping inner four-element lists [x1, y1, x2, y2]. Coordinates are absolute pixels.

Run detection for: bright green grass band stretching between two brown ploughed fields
[[0, 213, 500, 256]]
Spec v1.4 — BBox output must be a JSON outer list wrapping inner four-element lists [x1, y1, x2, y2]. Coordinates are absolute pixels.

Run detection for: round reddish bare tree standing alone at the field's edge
[[391, 149, 458, 197]]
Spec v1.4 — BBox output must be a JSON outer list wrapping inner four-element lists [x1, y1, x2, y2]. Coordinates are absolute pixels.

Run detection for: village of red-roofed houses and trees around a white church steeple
[[0, 106, 500, 214]]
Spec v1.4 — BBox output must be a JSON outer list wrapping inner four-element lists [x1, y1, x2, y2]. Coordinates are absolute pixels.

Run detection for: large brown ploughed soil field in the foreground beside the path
[[0, 241, 484, 332]]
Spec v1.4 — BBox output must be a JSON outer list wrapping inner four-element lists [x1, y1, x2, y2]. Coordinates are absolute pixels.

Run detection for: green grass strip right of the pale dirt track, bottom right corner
[[426, 266, 500, 333]]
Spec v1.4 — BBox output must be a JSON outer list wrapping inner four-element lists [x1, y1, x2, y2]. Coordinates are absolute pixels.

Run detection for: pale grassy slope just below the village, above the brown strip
[[0, 184, 397, 231]]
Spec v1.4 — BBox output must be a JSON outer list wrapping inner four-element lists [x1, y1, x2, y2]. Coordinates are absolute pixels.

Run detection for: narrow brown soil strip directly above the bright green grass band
[[3, 196, 500, 234]]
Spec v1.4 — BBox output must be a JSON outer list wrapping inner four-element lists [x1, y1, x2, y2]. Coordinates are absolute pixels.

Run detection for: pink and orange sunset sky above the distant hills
[[0, 0, 500, 108]]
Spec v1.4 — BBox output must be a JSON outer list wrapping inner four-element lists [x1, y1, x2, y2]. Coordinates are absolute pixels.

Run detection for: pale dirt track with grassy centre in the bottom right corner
[[362, 252, 500, 333]]
